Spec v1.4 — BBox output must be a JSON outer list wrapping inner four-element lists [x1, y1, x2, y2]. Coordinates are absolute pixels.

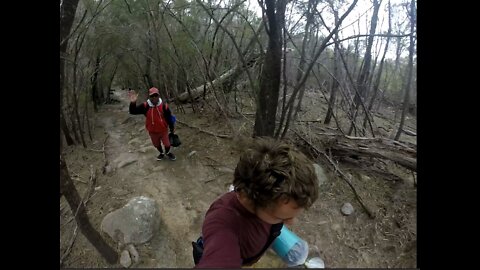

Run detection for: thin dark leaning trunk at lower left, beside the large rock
[[60, 155, 118, 264]]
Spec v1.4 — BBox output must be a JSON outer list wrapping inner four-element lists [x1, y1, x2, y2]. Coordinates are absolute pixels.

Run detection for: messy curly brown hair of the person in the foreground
[[233, 138, 318, 209]]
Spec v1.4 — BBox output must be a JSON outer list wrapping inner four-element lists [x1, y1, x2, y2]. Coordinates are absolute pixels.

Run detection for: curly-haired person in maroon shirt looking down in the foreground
[[194, 138, 318, 268]]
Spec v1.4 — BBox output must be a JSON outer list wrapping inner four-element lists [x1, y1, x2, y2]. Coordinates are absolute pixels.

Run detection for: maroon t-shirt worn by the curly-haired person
[[195, 191, 272, 268]]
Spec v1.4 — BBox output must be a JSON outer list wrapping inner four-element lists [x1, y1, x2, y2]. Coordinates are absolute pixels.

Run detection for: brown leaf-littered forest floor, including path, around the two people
[[59, 90, 417, 268]]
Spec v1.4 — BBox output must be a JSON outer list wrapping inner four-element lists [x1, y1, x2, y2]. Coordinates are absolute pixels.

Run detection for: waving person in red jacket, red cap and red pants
[[128, 87, 176, 160]]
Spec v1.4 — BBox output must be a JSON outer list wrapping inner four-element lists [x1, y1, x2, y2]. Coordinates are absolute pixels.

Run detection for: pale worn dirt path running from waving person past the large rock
[[61, 91, 244, 267]]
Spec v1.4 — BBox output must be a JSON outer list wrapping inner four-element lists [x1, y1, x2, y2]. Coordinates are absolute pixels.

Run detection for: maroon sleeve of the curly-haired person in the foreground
[[195, 209, 242, 268]]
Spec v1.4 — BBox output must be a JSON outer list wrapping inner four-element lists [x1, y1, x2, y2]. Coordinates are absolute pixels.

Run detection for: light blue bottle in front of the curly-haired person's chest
[[272, 225, 308, 267]]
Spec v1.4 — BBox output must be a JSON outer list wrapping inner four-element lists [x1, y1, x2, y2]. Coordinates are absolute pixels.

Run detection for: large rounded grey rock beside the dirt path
[[101, 196, 160, 244]]
